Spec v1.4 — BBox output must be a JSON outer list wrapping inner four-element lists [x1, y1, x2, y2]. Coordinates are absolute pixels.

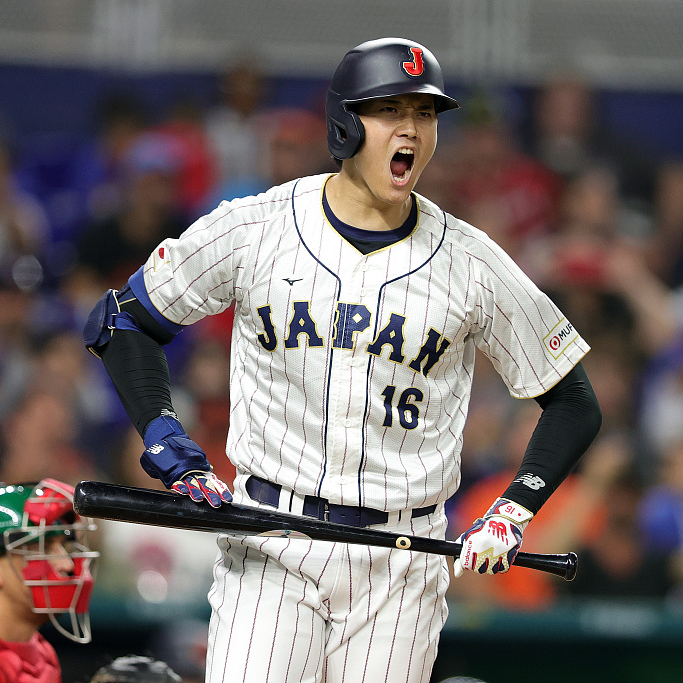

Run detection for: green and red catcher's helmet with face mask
[[0, 479, 99, 643]]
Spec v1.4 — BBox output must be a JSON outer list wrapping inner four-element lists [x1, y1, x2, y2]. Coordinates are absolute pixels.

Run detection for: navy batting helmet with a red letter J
[[325, 38, 460, 159]]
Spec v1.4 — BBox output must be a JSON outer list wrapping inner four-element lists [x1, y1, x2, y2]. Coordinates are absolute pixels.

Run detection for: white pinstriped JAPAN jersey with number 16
[[144, 175, 589, 511]]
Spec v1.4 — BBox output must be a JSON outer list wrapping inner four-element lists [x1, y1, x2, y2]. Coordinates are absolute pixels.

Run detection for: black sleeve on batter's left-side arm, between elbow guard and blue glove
[[100, 299, 175, 436]]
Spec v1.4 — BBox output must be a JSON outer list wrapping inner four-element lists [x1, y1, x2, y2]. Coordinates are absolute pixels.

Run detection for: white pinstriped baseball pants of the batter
[[206, 510, 448, 683]]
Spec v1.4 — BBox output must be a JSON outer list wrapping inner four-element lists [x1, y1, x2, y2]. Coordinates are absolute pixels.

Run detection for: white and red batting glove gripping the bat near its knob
[[453, 498, 534, 578]]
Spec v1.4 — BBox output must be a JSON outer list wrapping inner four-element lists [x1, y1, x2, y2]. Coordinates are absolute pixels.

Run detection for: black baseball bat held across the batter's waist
[[74, 481, 578, 581]]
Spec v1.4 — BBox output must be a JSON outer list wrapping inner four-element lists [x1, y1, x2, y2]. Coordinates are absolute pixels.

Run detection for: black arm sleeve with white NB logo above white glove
[[502, 363, 602, 514]]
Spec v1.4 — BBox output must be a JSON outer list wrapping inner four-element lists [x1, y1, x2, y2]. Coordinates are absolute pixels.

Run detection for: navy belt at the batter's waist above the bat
[[246, 475, 436, 527]]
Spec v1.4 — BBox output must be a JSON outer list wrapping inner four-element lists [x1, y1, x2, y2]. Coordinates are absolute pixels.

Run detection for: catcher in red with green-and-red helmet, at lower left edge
[[0, 479, 99, 683]]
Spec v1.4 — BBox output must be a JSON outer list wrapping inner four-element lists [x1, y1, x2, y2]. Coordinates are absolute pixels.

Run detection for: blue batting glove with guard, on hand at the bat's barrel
[[140, 415, 232, 507]]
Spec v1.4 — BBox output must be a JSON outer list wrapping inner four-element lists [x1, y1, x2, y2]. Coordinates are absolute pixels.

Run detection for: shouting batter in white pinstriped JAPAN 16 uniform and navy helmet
[[85, 38, 601, 683]]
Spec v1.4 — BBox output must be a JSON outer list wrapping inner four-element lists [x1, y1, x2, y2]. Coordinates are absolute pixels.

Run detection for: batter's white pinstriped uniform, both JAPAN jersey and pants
[[139, 176, 588, 683]]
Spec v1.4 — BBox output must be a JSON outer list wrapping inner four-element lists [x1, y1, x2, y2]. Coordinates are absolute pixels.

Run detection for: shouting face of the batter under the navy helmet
[[347, 94, 437, 204]]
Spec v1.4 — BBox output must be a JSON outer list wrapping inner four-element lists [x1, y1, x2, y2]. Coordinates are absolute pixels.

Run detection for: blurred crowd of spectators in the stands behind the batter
[[0, 3, 683, 680]]
